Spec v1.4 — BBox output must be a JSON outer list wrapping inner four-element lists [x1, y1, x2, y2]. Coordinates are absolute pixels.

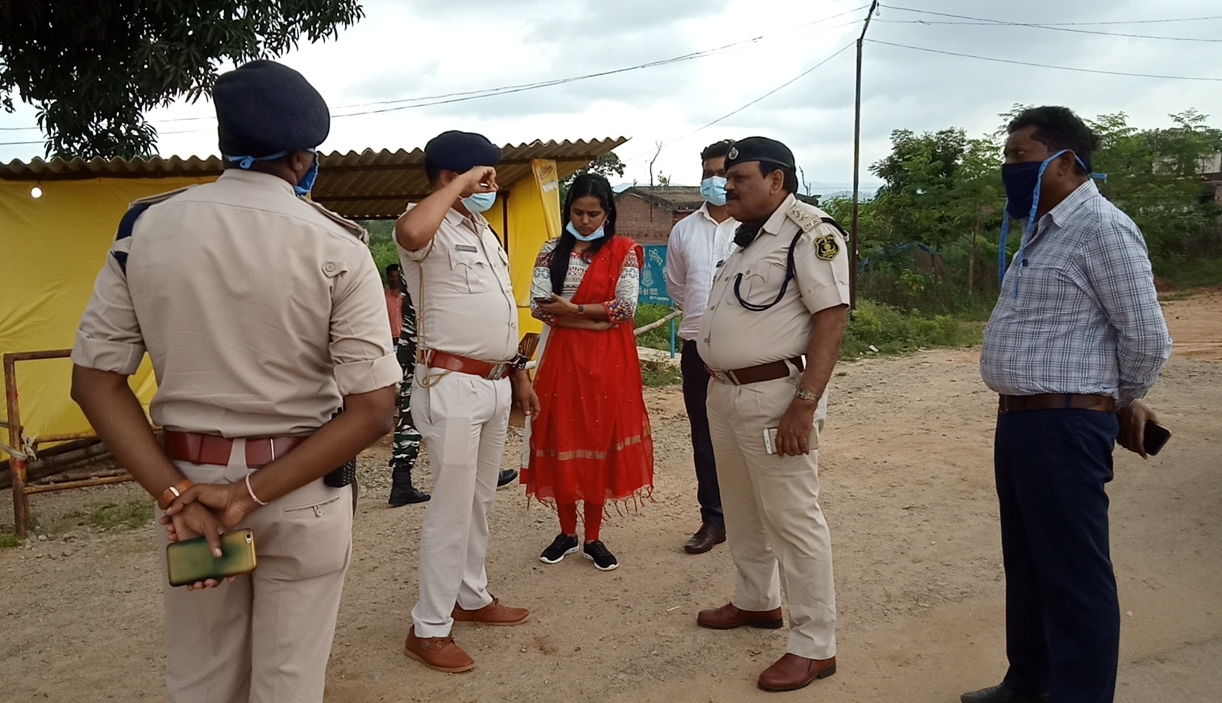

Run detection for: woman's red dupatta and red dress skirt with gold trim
[[522, 237, 654, 505]]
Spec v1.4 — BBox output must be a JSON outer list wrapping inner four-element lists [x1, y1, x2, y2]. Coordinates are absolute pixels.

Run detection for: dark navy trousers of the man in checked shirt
[[993, 410, 1121, 703]]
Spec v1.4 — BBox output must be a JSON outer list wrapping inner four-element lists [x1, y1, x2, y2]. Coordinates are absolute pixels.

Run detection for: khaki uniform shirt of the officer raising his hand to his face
[[398, 205, 518, 362]]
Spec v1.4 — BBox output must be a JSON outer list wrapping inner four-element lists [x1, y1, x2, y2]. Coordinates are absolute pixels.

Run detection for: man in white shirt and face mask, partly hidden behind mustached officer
[[666, 139, 738, 554]]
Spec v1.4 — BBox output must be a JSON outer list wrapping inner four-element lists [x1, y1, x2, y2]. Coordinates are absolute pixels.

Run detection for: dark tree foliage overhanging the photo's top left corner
[[0, 0, 364, 158]]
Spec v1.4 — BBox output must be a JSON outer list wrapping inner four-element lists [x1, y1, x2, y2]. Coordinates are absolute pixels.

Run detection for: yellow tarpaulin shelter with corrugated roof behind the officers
[[0, 138, 626, 444]]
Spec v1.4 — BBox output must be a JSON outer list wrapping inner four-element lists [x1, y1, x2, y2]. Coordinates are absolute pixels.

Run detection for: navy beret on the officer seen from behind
[[213, 60, 331, 158]]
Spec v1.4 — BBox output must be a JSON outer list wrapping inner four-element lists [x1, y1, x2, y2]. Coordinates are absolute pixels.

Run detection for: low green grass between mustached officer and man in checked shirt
[[841, 300, 985, 359]]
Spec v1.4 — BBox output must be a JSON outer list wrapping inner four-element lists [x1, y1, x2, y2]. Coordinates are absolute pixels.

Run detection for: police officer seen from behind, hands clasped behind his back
[[72, 61, 402, 703]]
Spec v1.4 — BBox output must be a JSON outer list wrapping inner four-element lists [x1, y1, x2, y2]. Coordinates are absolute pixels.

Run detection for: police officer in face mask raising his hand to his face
[[395, 131, 539, 672]]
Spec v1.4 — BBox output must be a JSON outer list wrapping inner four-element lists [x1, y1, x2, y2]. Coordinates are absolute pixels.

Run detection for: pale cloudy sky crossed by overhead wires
[[0, 0, 1222, 192]]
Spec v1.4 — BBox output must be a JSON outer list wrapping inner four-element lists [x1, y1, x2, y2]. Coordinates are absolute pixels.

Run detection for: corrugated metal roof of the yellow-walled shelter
[[0, 137, 628, 219]]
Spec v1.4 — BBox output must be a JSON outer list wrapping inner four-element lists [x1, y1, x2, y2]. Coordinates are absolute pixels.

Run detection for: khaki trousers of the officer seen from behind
[[158, 440, 353, 703]]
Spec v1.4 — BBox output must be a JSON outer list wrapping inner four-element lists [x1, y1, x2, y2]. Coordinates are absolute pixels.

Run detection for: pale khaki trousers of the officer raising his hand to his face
[[412, 366, 513, 637]]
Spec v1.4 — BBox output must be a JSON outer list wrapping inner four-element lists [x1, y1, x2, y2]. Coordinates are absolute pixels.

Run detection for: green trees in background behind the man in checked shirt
[[826, 105, 1222, 312]]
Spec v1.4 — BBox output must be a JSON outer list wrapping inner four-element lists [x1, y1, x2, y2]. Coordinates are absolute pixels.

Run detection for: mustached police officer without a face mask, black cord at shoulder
[[697, 137, 848, 691]]
